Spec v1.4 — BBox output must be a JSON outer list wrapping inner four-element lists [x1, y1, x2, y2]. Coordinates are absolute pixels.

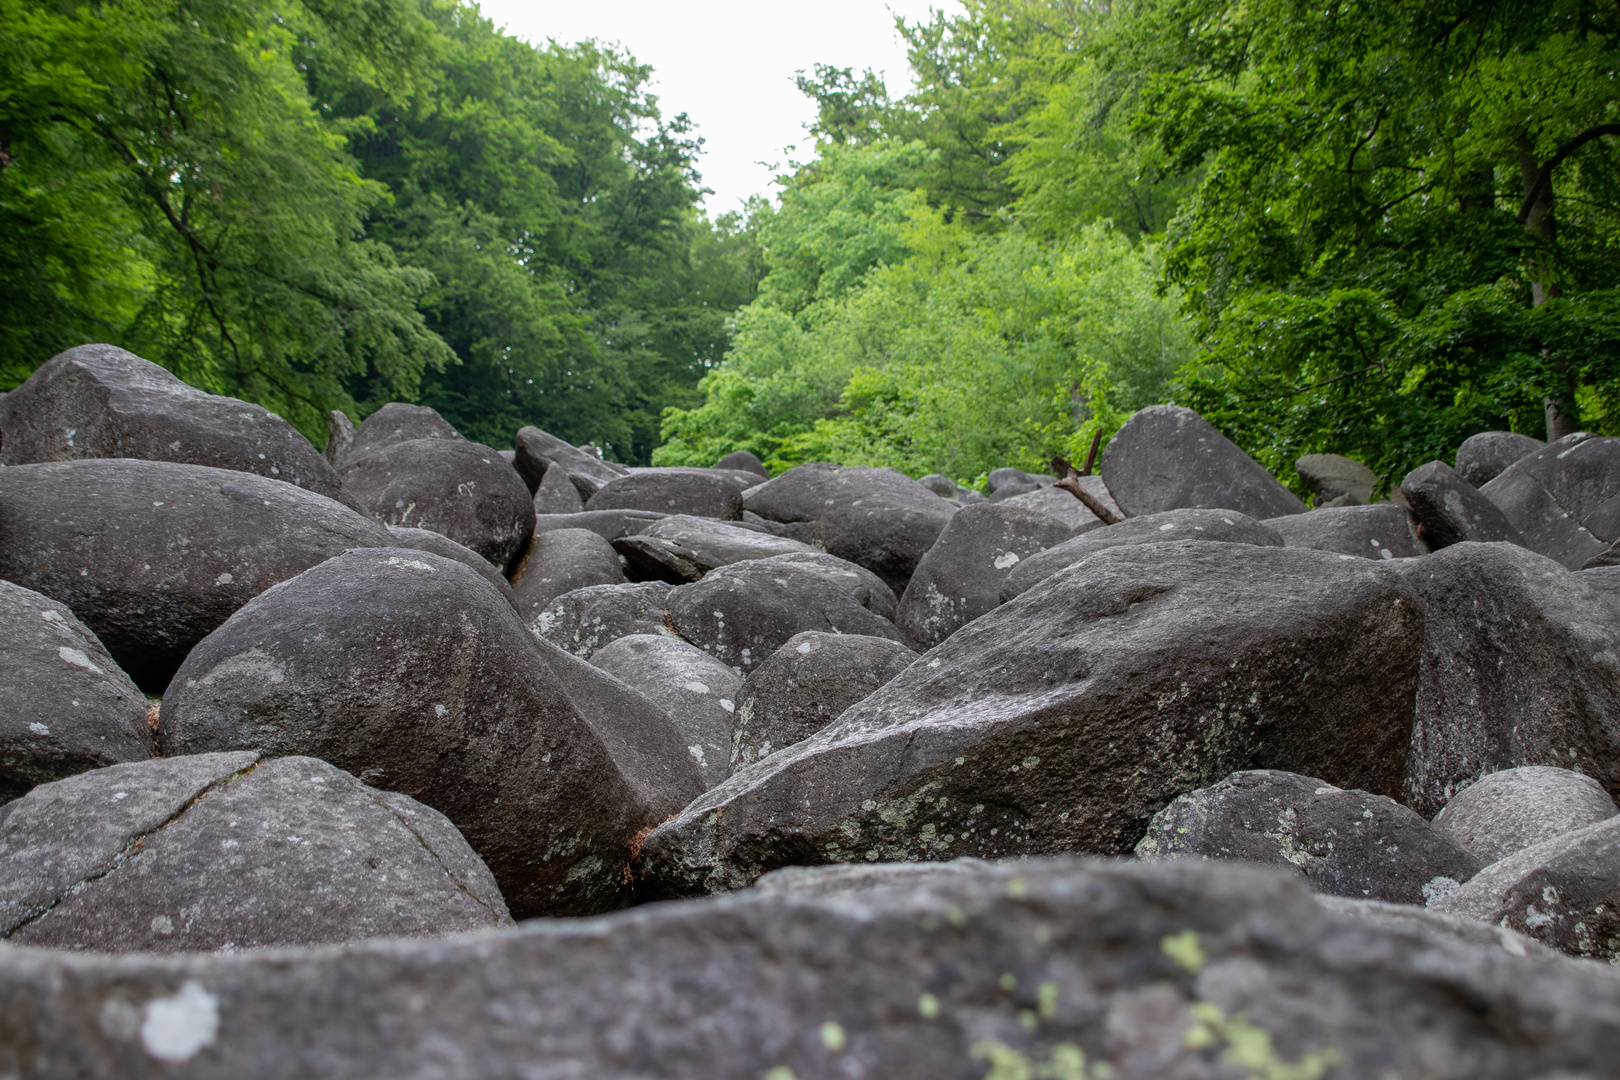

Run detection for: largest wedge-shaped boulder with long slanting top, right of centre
[[642, 541, 1422, 895]]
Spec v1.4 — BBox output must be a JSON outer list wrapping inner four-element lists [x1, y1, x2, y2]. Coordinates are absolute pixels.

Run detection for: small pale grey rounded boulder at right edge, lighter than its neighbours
[[1434, 766, 1620, 863]]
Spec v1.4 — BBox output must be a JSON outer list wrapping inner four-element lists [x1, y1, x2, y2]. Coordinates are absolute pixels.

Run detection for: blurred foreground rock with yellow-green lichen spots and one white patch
[[0, 860, 1620, 1080]]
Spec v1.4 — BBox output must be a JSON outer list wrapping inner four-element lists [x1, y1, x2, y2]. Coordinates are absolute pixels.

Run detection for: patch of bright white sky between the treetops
[[481, 0, 961, 214]]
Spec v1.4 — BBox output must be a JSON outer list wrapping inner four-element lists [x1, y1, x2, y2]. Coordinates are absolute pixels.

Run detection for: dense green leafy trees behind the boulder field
[[0, 0, 1620, 491]]
